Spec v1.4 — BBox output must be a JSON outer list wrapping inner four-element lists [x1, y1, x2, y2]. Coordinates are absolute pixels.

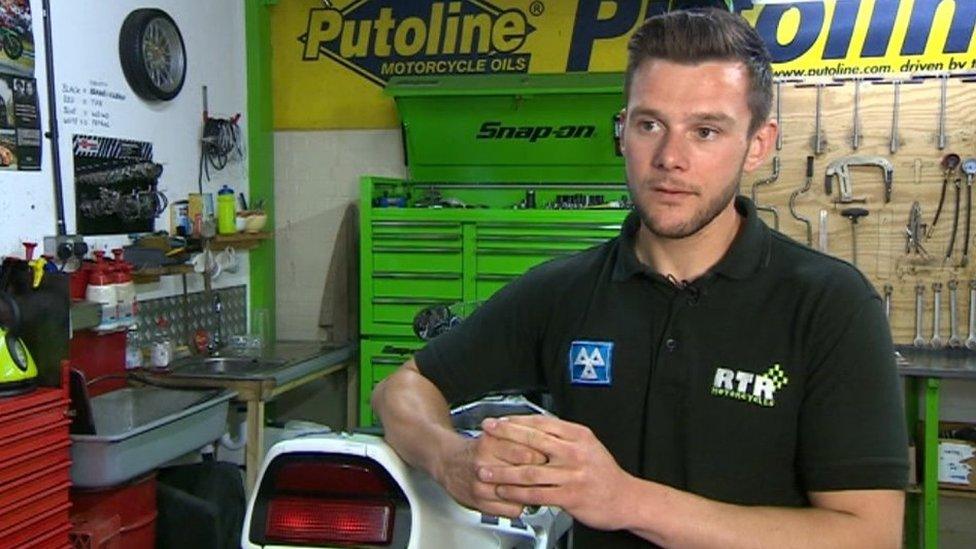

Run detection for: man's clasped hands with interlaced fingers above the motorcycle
[[439, 415, 634, 530]]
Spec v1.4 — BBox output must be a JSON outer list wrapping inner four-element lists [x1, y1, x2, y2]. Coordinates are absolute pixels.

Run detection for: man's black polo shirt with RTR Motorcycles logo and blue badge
[[415, 197, 908, 547]]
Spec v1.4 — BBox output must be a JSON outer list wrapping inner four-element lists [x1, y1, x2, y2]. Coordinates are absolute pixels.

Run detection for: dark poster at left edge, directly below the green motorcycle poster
[[0, 74, 41, 171]]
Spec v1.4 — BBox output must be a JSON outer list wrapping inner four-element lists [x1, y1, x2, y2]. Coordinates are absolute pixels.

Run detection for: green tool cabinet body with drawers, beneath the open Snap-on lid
[[360, 188, 626, 425]]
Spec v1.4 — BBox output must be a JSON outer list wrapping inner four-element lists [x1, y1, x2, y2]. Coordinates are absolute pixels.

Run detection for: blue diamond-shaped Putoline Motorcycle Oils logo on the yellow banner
[[298, 0, 535, 86]]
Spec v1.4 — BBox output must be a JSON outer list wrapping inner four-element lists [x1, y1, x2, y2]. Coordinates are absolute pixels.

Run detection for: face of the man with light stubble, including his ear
[[622, 59, 775, 239]]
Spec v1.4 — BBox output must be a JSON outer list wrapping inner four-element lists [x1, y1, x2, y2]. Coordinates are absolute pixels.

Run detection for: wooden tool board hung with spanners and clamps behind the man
[[756, 75, 976, 344]]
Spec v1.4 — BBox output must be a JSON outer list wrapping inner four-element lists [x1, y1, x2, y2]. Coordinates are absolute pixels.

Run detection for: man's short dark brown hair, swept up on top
[[624, 8, 773, 135]]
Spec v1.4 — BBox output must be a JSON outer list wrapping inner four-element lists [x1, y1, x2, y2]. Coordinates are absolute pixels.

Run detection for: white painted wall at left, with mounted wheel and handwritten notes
[[0, 0, 248, 299]]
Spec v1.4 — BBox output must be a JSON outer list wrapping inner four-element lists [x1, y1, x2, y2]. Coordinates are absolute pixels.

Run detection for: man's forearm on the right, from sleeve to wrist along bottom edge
[[625, 479, 903, 548]]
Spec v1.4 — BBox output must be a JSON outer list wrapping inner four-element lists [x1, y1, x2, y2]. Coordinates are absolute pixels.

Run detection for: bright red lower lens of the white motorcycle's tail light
[[265, 497, 394, 545]]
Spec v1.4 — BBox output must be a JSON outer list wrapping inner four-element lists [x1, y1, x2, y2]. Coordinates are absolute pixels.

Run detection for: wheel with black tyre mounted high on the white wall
[[119, 8, 186, 101]]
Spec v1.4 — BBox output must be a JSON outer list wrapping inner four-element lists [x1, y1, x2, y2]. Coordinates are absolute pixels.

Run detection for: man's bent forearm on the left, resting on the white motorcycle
[[372, 361, 464, 478]]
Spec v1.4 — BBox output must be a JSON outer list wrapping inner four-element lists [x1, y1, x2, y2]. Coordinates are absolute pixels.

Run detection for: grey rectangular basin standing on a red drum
[[71, 386, 236, 488]]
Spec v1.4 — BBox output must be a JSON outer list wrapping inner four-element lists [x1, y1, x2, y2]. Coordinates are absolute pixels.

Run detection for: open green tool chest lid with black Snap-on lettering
[[386, 73, 624, 183]]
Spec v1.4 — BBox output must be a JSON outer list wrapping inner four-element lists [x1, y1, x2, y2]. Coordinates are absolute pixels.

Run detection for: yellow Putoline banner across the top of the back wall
[[271, 0, 976, 129]]
